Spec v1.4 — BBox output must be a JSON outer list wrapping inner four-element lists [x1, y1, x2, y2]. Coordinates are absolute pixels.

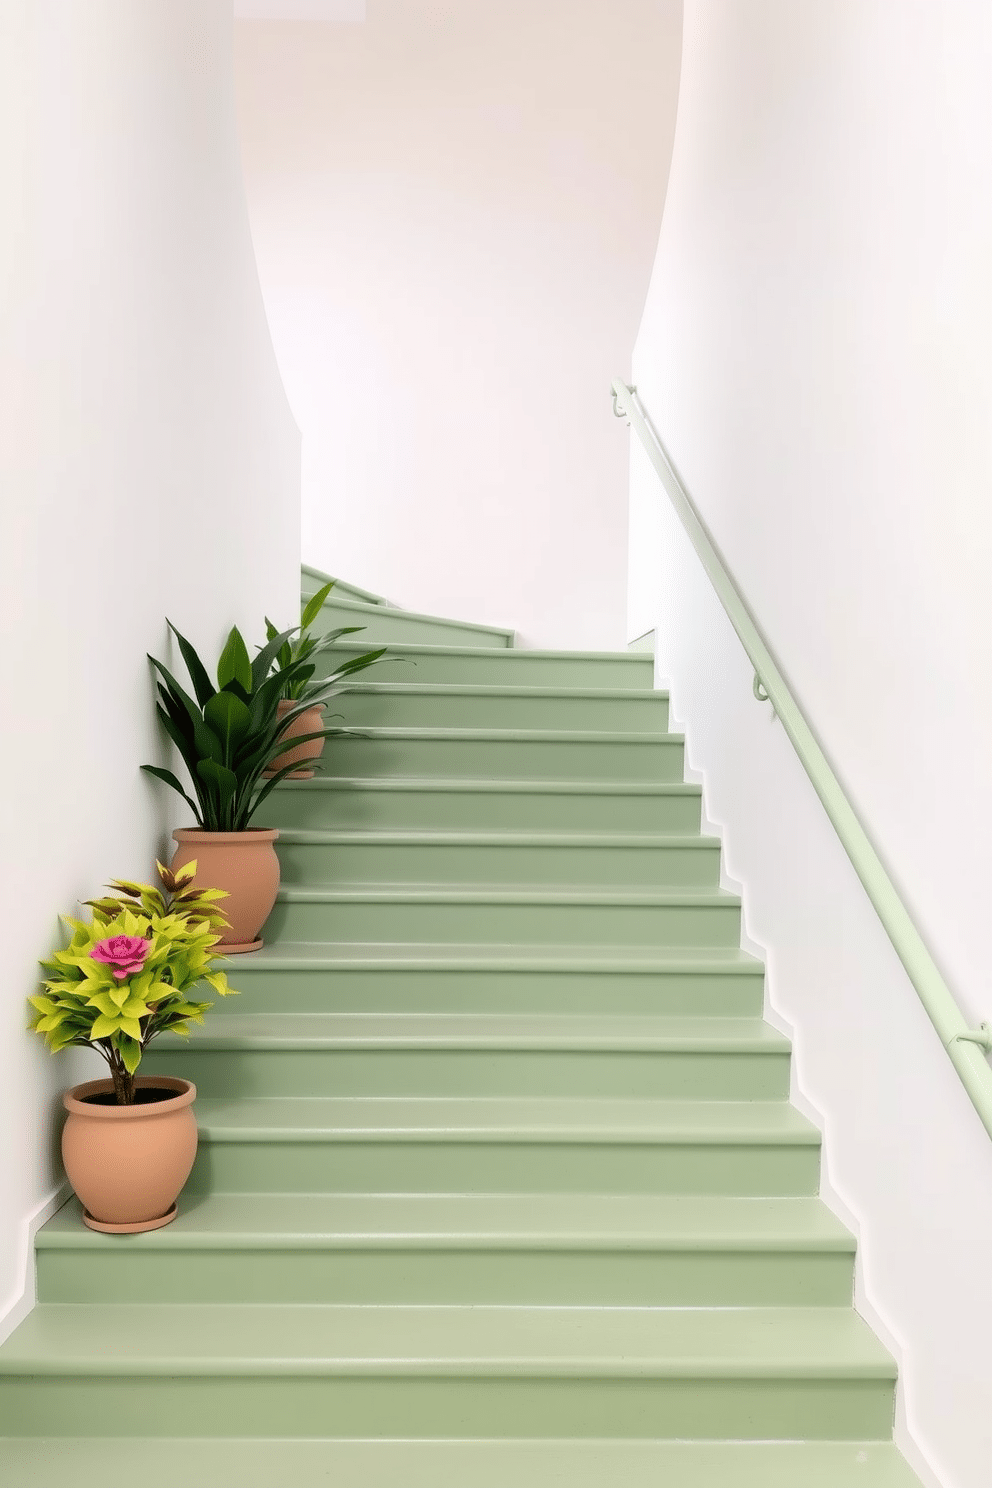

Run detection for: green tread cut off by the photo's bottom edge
[[0, 1437, 919, 1488]]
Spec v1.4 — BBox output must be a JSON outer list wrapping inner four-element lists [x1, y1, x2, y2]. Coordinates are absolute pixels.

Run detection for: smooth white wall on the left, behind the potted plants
[[0, 0, 299, 1326]]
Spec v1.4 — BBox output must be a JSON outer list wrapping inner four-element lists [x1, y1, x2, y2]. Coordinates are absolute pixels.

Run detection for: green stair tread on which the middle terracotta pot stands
[[228, 940, 764, 979]]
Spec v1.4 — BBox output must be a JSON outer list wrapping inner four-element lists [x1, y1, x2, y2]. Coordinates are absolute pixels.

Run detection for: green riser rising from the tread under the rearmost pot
[[323, 734, 683, 783]]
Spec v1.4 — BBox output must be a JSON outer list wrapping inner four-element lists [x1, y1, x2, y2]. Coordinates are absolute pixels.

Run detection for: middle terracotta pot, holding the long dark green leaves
[[173, 827, 280, 955]]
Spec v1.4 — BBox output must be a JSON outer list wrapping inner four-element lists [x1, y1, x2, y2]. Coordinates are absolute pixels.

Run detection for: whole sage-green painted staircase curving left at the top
[[0, 570, 918, 1488]]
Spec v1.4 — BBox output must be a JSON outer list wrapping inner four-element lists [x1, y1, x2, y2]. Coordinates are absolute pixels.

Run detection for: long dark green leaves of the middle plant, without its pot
[[141, 620, 364, 832]]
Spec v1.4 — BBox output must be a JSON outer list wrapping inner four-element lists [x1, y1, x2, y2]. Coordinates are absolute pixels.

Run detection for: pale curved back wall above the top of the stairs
[[235, 0, 681, 646]]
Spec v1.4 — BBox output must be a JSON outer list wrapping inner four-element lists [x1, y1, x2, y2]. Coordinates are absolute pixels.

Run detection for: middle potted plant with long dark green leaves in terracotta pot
[[141, 620, 356, 955]]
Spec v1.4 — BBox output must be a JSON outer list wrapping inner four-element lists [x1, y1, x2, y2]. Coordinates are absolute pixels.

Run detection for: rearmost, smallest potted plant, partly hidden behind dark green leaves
[[265, 579, 385, 780]]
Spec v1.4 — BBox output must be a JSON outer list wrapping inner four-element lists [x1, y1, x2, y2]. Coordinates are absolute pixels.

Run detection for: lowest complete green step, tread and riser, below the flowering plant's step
[[0, 1303, 895, 1442]]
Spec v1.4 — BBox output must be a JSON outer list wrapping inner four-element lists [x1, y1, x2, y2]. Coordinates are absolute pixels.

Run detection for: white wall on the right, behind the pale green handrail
[[629, 0, 992, 1488]]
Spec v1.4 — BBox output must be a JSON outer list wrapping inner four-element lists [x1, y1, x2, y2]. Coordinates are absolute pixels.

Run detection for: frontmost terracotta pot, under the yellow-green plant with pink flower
[[62, 1074, 196, 1234]]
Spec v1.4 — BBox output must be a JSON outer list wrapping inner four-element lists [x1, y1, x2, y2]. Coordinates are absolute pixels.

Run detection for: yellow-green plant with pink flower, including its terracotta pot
[[30, 863, 232, 1232]]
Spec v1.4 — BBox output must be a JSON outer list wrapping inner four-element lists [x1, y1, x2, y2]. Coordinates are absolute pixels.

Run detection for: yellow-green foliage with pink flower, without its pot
[[28, 863, 232, 1106]]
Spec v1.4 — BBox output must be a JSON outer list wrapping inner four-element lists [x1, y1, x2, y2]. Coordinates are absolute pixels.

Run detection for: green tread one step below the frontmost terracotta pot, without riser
[[0, 1302, 895, 1381]]
